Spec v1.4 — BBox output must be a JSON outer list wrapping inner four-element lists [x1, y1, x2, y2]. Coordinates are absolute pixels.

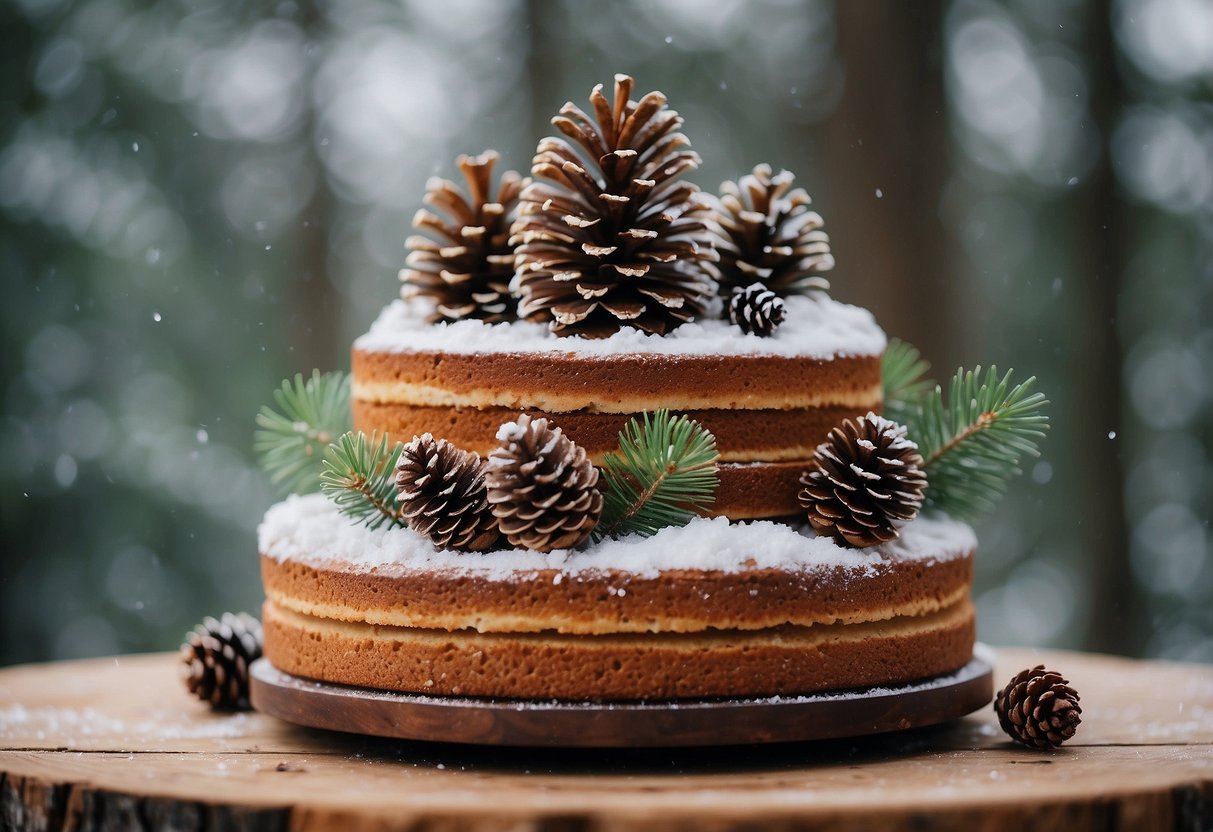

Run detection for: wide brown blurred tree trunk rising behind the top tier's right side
[[821, 2, 961, 367]]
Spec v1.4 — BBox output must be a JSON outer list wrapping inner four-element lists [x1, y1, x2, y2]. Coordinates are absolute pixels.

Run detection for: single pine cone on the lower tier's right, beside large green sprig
[[799, 414, 927, 548]]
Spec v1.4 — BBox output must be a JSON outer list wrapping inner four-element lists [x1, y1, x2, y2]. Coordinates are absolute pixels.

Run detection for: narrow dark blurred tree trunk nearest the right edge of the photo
[[1067, 0, 1149, 655]]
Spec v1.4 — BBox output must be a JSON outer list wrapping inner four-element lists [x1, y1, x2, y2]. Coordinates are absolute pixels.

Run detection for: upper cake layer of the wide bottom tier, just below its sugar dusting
[[261, 552, 973, 634]]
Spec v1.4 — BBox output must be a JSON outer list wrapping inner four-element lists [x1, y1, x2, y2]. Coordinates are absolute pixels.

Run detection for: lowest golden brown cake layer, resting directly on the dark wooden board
[[263, 599, 975, 700]]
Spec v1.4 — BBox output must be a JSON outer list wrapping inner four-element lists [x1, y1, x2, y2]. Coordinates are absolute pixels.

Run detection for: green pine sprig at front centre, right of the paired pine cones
[[594, 410, 721, 540]]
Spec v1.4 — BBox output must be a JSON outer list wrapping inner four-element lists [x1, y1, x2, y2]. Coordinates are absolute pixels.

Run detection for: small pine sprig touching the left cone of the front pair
[[320, 431, 405, 529]]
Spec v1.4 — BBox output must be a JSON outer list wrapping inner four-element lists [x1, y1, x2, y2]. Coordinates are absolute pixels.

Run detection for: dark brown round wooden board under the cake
[[251, 645, 993, 748]]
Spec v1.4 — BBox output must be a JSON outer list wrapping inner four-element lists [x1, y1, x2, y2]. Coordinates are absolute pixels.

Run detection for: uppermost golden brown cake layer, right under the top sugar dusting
[[352, 347, 881, 414]]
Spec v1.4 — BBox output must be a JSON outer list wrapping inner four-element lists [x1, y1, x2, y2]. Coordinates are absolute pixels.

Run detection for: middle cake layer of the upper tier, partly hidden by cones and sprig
[[353, 400, 867, 462]]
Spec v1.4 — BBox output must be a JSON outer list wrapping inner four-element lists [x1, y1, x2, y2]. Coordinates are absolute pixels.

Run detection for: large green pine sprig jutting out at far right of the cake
[[909, 366, 1049, 520]]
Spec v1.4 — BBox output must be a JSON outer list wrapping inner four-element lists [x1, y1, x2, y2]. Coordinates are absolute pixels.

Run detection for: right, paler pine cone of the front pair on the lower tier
[[484, 414, 603, 552]]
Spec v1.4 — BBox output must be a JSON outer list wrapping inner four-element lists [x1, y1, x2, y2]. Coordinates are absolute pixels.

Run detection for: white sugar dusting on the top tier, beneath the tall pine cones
[[354, 295, 887, 359]]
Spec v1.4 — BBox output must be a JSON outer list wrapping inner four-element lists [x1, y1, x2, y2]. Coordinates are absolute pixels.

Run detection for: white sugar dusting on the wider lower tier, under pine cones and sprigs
[[257, 494, 976, 580]]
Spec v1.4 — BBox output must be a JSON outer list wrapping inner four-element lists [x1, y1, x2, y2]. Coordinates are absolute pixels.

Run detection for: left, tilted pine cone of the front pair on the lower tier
[[395, 433, 499, 552]]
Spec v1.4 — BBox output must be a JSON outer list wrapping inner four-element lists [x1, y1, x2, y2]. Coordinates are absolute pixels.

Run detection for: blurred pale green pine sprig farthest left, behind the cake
[[252, 370, 353, 494]]
